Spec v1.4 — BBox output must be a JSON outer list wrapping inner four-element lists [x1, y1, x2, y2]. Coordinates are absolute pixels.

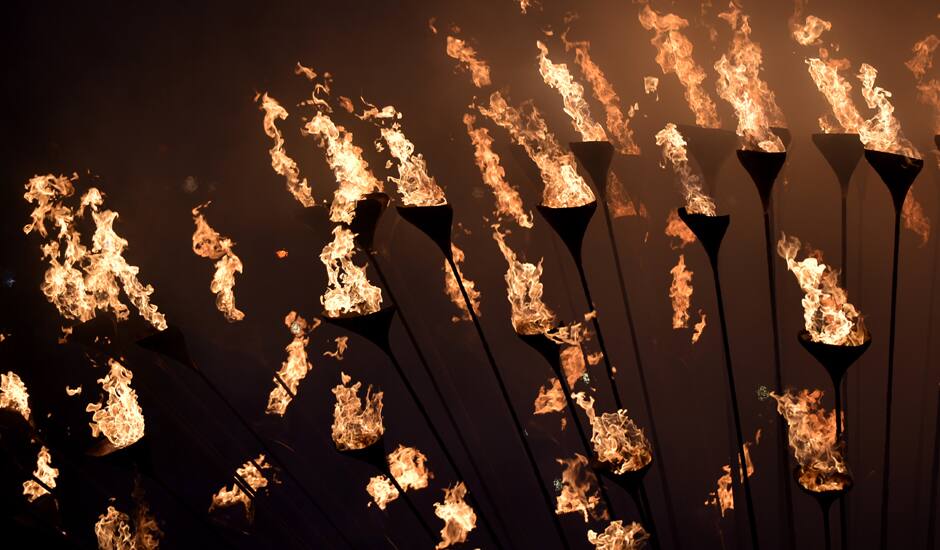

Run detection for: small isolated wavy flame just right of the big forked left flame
[[193, 202, 245, 323]]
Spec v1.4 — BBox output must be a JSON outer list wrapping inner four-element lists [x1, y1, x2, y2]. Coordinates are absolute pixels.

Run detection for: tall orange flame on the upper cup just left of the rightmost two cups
[[715, 2, 786, 153]]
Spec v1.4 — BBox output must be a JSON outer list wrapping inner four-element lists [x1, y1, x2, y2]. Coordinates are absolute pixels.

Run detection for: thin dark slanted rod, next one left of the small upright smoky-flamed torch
[[601, 200, 682, 549]]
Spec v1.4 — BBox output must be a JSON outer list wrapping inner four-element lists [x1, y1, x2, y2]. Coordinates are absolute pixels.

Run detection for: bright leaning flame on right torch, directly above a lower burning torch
[[777, 234, 868, 346]]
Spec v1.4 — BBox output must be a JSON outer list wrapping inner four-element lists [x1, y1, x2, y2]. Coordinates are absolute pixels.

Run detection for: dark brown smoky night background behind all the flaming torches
[[0, 0, 938, 548]]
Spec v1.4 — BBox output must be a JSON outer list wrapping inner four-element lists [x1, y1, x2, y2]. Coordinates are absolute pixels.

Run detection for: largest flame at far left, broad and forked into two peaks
[[23, 174, 167, 330]]
